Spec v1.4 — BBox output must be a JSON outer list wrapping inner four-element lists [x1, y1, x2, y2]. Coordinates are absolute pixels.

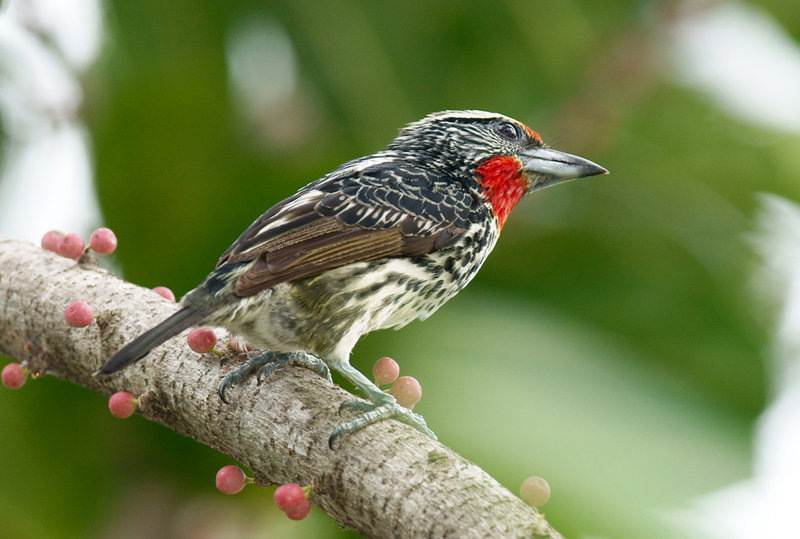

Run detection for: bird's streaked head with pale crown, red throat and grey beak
[[388, 110, 608, 227]]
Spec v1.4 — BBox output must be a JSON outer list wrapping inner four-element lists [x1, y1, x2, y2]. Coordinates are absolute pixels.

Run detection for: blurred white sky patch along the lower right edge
[[668, 196, 800, 539]]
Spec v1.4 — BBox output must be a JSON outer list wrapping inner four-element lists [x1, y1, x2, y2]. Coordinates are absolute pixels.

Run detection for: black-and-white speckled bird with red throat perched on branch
[[95, 110, 608, 448]]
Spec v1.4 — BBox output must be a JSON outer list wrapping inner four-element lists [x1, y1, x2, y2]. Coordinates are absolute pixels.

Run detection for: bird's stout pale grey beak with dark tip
[[520, 148, 608, 191]]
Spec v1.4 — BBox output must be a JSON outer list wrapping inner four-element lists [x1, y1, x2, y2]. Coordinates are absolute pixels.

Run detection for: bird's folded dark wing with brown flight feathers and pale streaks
[[217, 162, 473, 296]]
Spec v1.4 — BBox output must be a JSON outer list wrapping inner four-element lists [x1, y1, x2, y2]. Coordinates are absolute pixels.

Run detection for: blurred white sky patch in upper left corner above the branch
[[0, 0, 102, 242]]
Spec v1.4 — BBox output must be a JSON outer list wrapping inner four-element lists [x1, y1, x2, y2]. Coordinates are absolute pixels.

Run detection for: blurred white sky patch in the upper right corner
[[671, 3, 800, 132]]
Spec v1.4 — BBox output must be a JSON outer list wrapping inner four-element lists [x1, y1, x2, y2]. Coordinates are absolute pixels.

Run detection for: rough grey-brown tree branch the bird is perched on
[[0, 237, 561, 537]]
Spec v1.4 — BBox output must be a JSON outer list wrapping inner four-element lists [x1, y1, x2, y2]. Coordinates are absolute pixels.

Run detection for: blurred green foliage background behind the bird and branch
[[6, 0, 800, 538]]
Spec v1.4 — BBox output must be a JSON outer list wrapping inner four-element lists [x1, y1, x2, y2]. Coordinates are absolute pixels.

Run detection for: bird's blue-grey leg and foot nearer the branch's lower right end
[[328, 362, 436, 448]]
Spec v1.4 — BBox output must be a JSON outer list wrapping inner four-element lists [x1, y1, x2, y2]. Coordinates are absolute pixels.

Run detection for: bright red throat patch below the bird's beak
[[475, 155, 527, 229]]
